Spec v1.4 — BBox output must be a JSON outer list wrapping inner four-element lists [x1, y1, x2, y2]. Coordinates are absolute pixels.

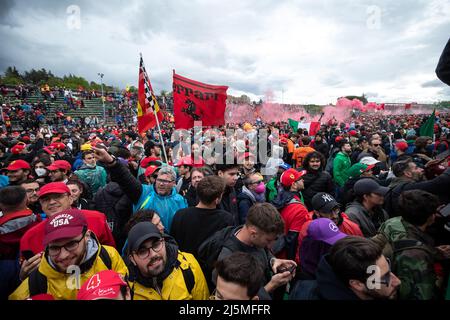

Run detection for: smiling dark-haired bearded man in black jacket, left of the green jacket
[[302, 151, 334, 210]]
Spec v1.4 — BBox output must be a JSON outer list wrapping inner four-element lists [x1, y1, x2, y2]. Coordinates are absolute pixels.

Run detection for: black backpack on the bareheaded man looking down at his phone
[[197, 226, 236, 289]]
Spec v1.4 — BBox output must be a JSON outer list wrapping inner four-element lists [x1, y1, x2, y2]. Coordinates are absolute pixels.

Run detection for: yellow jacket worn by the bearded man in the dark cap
[[129, 251, 209, 300]]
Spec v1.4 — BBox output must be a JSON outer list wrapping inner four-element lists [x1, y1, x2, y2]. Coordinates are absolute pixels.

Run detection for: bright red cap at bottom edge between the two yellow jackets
[[77, 270, 128, 300]]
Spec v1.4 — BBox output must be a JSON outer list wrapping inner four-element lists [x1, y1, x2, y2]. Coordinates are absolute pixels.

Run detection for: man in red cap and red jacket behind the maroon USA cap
[[20, 182, 115, 279]]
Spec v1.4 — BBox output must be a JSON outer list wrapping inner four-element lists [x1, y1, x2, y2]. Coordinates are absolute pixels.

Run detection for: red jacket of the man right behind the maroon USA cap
[[20, 210, 116, 254]]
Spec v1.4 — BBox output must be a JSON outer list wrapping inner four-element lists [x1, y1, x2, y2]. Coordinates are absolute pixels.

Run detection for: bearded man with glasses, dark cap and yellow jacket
[[128, 222, 209, 300]]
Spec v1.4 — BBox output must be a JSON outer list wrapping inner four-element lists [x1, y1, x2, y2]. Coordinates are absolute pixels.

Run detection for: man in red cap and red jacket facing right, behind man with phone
[[272, 169, 311, 262]]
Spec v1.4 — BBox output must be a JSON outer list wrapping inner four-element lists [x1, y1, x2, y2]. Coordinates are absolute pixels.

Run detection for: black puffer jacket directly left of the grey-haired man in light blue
[[94, 182, 133, 251]]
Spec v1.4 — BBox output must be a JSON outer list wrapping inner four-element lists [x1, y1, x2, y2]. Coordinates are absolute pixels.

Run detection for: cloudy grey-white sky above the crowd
[[0, 0, 450, 104]]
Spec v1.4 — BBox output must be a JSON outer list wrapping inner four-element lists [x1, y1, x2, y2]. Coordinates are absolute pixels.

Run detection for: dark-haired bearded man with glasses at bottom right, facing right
[[291, 236, 401, 300]]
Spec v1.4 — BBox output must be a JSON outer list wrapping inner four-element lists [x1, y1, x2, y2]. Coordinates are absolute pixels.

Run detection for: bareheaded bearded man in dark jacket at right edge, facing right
[[384, 159, 450, 217]]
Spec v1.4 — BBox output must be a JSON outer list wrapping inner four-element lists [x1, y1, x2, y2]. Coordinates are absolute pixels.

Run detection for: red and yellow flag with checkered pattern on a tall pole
[[137, 56, 163, 135]]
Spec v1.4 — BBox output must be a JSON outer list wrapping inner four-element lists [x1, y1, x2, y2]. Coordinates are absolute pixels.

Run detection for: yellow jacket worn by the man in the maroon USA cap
[[9, 239, 128, 300]]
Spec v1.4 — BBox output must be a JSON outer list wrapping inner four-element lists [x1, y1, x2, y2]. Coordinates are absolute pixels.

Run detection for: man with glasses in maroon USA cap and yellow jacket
[[9, 209, 128, 300]]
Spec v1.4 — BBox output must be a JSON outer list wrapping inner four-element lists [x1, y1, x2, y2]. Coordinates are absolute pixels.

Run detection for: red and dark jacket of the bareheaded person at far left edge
[[0, 209, 41, 260]]
